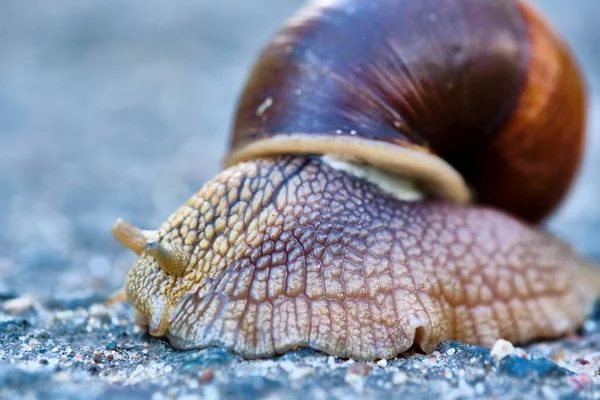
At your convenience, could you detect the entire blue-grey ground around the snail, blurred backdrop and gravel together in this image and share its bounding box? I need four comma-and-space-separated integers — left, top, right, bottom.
0, 0, 600, 399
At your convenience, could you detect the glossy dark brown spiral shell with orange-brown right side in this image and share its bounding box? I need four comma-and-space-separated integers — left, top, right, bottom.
227, 0, 585, 222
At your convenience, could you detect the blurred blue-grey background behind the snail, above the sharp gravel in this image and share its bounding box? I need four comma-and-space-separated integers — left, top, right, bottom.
0, 0, 600, 298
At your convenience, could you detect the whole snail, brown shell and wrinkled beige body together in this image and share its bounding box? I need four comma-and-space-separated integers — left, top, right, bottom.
113, 0, 594, 360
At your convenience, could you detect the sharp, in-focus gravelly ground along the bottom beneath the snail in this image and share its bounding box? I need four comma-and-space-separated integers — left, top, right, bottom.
0, 300, 600, 399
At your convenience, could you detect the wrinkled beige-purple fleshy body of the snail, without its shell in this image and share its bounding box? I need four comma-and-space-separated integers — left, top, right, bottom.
126, 157, 591, 360
